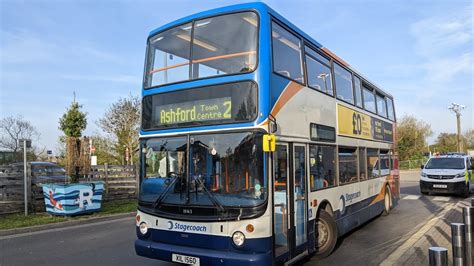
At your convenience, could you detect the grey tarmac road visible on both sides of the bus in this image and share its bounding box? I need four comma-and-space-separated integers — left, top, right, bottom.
0, 171, 460, 265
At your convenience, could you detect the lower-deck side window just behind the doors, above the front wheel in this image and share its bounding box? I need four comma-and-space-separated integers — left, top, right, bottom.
309, 145, 336, 191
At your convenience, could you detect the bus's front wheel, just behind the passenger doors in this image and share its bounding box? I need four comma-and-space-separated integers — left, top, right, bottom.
315, 210, 337, 258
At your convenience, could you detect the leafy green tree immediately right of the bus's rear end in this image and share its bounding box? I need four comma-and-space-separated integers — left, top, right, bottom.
397, 115, 433, 160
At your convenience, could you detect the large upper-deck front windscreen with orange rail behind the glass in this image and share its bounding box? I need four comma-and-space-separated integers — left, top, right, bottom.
144, 12, 258, 88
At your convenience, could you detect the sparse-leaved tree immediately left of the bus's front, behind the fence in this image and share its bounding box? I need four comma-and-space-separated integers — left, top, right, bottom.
97, 95, 140, 164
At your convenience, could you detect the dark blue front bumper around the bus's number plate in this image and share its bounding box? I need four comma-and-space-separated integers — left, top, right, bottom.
135, 239, 273, 266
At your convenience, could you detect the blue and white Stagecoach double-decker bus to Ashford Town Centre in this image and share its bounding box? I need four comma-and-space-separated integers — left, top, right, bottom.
135, 3, 399, 265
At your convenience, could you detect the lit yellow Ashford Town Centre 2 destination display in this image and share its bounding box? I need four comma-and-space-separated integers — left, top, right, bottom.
155, 97, 232, 125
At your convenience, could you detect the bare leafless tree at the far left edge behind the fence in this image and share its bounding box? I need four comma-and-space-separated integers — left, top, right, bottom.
0, 115, 39, 152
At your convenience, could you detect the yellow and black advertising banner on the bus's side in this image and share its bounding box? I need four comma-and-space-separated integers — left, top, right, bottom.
337, 105, 393, 142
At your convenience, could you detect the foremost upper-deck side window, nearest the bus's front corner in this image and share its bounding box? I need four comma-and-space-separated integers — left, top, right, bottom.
272, 22, 304, 83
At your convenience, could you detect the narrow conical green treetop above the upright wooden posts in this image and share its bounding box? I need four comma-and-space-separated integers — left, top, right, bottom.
59, 99, 87, 138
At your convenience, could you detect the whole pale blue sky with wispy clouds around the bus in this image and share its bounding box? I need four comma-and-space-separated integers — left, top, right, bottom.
0, 0, 474, 154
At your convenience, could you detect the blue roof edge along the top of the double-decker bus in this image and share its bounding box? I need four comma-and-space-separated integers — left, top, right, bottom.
148, 2, 393, 98
